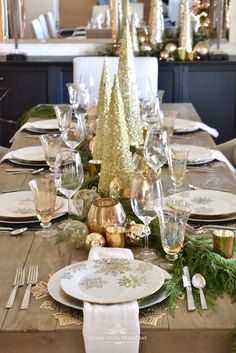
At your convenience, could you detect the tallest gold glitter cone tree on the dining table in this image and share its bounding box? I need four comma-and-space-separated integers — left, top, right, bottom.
118, 20, 143, 146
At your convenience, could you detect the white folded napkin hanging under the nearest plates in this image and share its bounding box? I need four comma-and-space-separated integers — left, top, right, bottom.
83, 247, 140, 353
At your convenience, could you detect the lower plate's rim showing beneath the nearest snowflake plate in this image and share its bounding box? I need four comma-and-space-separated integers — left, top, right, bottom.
48, 264, 171, 310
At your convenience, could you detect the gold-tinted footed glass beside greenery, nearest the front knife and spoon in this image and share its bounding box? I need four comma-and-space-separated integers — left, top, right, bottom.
158, 201, 190, 269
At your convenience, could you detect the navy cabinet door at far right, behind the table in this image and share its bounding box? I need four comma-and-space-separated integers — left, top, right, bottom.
183, 63, 236, 143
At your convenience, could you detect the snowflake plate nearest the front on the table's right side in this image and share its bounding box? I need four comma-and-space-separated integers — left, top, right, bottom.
167, 190, 236, 220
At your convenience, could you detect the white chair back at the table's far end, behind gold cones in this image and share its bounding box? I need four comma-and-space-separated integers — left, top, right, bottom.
73, 56, 158, 97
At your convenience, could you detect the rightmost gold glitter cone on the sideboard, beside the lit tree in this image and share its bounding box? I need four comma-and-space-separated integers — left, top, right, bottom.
179, 0, 193, 53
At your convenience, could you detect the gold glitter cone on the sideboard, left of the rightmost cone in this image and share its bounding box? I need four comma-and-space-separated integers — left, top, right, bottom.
149, 0, 164, 48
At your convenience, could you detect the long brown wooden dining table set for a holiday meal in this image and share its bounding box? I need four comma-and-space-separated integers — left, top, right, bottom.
0, 104, 236, 353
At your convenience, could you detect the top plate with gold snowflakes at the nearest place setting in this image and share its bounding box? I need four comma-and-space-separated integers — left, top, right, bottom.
61, 258, 164, 304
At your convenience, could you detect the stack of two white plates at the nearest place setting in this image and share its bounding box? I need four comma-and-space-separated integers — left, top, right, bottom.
48, 258, 170, 310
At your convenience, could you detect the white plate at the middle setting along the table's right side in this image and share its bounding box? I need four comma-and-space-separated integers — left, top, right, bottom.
171, 144, 215, 164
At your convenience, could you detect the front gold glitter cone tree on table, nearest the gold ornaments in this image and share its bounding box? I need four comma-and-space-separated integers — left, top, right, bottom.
98, 76, 132, 195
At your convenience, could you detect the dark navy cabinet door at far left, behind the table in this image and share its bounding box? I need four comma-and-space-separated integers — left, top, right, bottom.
0, 63, 55, 146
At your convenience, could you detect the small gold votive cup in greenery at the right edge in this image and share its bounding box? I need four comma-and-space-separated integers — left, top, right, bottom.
213, 229, 235, 259
